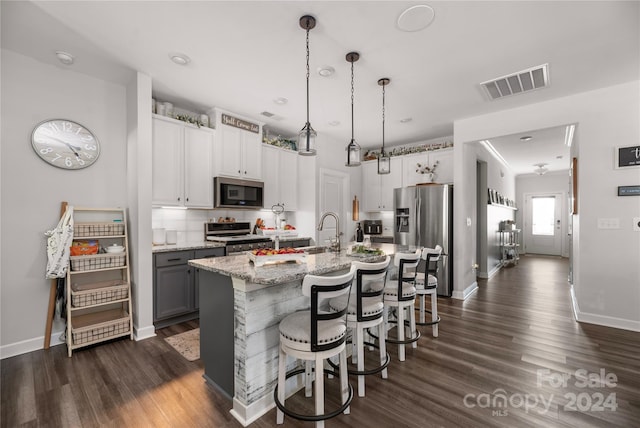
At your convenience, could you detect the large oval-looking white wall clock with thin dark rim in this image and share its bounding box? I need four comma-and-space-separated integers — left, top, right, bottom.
31, 119, 100, 169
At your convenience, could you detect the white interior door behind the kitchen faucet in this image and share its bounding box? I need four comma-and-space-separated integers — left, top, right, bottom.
317, 169, 348, 246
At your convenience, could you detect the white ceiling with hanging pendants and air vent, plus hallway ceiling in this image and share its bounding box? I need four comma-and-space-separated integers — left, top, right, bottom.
0, 1, 640, 174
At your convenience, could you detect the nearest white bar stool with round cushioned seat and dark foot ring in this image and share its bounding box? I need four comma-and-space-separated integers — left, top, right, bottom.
273, 266, 356, 427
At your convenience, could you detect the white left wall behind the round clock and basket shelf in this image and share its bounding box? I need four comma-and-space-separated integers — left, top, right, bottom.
0, 49, 127, 357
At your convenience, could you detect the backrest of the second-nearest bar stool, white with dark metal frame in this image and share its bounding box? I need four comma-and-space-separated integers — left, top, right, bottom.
351, 256, 391, 322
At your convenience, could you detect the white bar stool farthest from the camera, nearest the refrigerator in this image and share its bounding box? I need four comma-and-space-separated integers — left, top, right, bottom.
416, 245, 442, 337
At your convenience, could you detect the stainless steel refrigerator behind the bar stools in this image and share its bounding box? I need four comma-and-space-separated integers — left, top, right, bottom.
393, 184, 453, 297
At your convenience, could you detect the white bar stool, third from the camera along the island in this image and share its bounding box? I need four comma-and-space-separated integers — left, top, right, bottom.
384, 248, 422, 361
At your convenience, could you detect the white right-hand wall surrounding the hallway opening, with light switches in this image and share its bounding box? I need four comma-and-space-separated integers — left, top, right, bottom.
454, 81, 640, 331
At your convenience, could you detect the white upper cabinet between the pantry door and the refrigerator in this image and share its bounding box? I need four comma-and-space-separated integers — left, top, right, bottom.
362, 157, 402, 212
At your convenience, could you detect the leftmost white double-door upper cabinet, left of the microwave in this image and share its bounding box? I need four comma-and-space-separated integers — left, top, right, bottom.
151, 116, 214, 208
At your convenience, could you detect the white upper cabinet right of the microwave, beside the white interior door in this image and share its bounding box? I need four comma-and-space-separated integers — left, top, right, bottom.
262, 145, 298, 211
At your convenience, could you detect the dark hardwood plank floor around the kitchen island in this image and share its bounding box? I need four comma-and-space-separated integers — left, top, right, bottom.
0, 256, 640, 428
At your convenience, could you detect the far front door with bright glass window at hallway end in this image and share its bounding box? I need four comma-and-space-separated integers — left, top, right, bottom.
524, 193, 562, 256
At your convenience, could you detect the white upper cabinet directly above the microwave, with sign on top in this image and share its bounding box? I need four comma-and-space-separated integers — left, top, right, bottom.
215, 109, 263, 180
